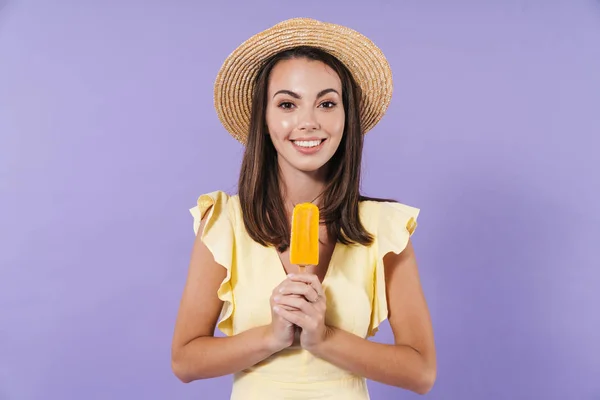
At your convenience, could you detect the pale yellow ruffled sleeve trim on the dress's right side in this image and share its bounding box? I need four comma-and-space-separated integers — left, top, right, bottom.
369, 203, 420, 336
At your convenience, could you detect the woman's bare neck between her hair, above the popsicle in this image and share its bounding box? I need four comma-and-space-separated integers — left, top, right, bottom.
279, 159, 325, 212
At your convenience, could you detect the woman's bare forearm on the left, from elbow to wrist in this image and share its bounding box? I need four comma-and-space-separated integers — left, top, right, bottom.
173, 326, 277, 383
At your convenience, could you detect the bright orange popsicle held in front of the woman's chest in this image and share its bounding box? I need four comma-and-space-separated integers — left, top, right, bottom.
290, 203, 319, 269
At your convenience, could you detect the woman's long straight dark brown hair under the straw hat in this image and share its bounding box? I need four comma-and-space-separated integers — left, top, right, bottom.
238, 47, 393, 252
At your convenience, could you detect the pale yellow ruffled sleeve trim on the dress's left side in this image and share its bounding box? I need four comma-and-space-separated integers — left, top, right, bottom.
190, 191, 235, 336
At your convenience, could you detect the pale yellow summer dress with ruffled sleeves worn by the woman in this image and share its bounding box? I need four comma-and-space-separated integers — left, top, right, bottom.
190, 191, 419, 400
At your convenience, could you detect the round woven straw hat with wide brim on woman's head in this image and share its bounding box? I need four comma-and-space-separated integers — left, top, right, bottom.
214, 18, 393, 144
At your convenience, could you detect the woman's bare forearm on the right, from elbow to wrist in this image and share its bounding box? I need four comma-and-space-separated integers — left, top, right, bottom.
311, 328, 435, 394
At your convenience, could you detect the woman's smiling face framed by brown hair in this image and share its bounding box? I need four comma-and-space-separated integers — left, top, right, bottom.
266, 58, 345, 172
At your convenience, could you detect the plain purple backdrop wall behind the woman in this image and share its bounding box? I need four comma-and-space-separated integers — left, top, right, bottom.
0, 0, 600, 400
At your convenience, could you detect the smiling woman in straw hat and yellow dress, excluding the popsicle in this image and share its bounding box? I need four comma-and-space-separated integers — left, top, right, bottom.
172, 19, 436, 400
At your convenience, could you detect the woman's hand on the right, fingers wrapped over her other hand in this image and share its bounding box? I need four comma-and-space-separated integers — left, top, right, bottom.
275, 274, 329, 351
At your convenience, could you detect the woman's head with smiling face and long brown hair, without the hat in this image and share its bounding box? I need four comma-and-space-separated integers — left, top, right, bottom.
238, 46, 372, 252
